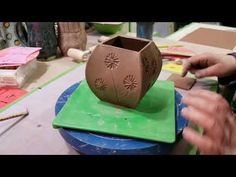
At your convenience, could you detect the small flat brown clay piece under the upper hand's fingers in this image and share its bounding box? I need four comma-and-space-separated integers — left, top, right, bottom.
167, 74, 196, 90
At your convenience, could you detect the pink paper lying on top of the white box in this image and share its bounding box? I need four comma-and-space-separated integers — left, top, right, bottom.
0, 47, 41, 66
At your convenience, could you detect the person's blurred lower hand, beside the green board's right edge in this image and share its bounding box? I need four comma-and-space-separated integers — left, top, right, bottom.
181, 90, 236, 154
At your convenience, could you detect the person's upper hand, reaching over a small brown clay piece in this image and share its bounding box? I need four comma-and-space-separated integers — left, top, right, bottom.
182, 53, 236, 78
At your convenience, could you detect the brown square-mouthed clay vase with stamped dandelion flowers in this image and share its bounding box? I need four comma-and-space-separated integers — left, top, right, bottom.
85, 36, 162, 108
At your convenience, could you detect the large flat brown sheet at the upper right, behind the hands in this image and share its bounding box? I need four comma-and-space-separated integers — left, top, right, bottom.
180, 28, 236, 50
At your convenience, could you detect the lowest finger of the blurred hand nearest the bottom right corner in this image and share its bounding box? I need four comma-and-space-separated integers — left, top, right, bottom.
183, 127, 220, 154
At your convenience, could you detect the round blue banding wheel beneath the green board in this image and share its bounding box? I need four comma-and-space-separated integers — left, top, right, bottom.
55, 83, 187, 155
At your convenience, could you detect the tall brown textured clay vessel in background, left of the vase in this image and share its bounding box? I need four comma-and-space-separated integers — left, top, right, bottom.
58, 22, 87, 56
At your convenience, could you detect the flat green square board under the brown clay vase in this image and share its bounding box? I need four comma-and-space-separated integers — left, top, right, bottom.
53, 80, 176, 143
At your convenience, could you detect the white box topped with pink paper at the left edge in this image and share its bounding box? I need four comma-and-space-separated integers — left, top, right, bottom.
0, 47, 40, 88
